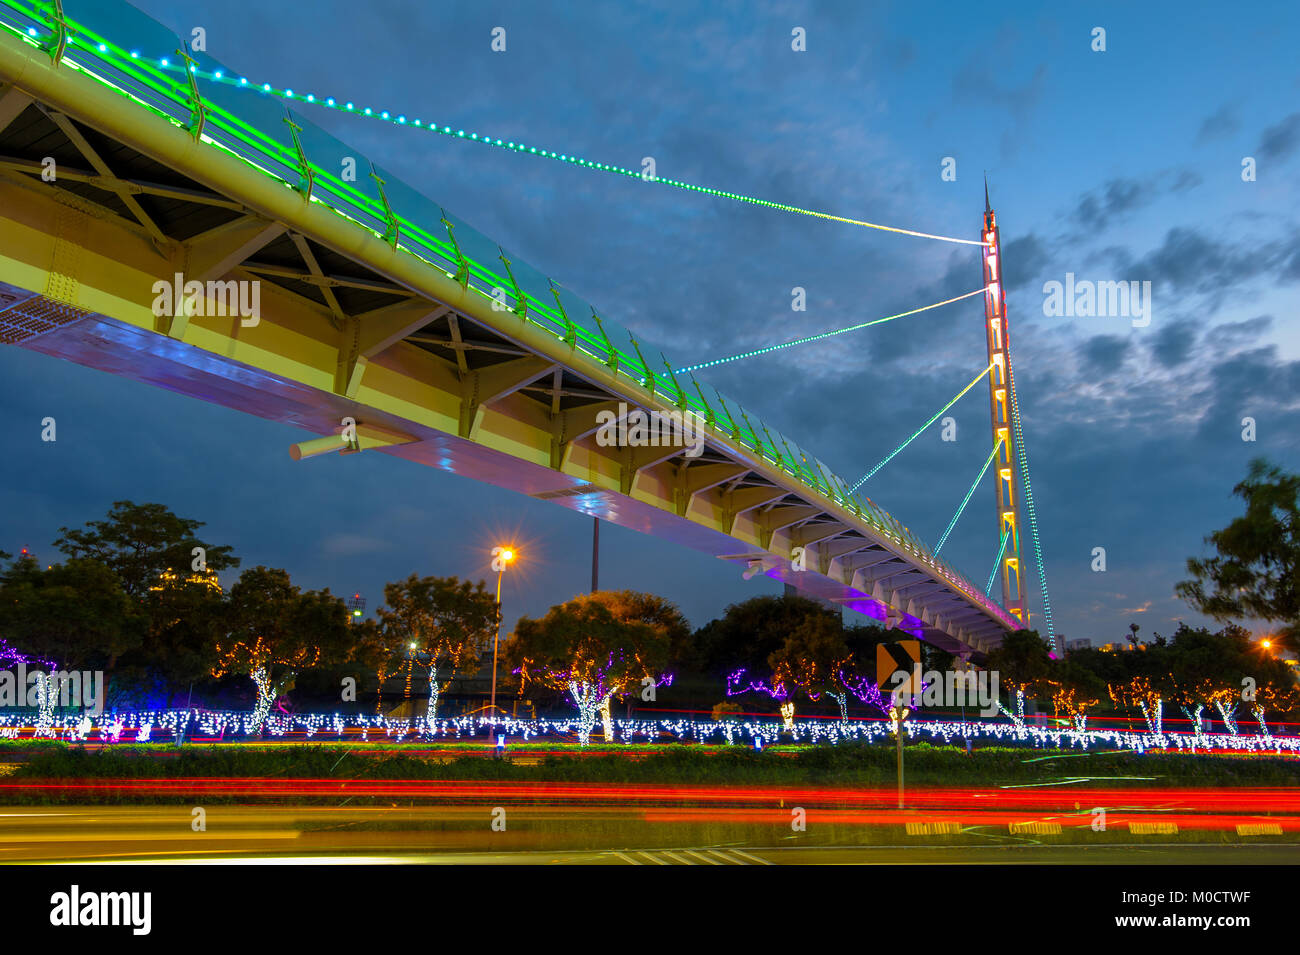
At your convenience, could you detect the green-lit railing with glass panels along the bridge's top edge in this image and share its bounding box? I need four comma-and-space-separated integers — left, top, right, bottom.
0, 0, 1014, 631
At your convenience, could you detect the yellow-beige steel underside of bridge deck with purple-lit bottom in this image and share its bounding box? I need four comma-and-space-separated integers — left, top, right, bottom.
0, 51, 1008, 659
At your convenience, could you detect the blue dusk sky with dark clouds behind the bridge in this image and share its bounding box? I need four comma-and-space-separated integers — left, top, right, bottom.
0, 0, 1300, 643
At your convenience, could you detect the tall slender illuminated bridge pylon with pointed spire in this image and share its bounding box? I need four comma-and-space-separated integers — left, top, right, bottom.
982, 179, 1028, 626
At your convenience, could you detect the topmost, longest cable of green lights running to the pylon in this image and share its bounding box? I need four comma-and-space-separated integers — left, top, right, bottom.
131, 64, 987, 246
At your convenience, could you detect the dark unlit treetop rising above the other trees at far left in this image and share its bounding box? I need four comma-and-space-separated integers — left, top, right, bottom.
55, 500, 239, 598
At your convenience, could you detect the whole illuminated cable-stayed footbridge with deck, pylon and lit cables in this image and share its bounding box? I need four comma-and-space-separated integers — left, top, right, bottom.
0, 0, 1050, 655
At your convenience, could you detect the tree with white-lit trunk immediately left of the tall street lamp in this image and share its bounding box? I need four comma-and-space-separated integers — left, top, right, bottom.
378, 574, 497, 724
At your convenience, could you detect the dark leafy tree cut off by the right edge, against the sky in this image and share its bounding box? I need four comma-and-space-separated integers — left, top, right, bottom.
1177, 457, 1300, 652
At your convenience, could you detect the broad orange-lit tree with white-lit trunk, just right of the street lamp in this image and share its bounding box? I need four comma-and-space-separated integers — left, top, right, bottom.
506, 592, 672, 746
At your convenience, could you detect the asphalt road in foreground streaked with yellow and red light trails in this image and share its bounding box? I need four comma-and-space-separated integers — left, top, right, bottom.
0, 804, 1300, 865
